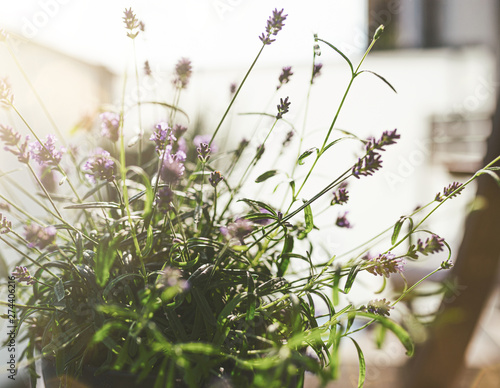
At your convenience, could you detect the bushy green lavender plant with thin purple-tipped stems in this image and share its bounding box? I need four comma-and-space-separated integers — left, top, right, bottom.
0, 9, 498, 387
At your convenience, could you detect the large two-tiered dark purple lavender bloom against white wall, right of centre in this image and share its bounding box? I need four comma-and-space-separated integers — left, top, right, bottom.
352, 129, 401, 179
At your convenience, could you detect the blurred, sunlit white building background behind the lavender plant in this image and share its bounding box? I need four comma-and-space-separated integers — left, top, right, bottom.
0, 0, 500, 387
